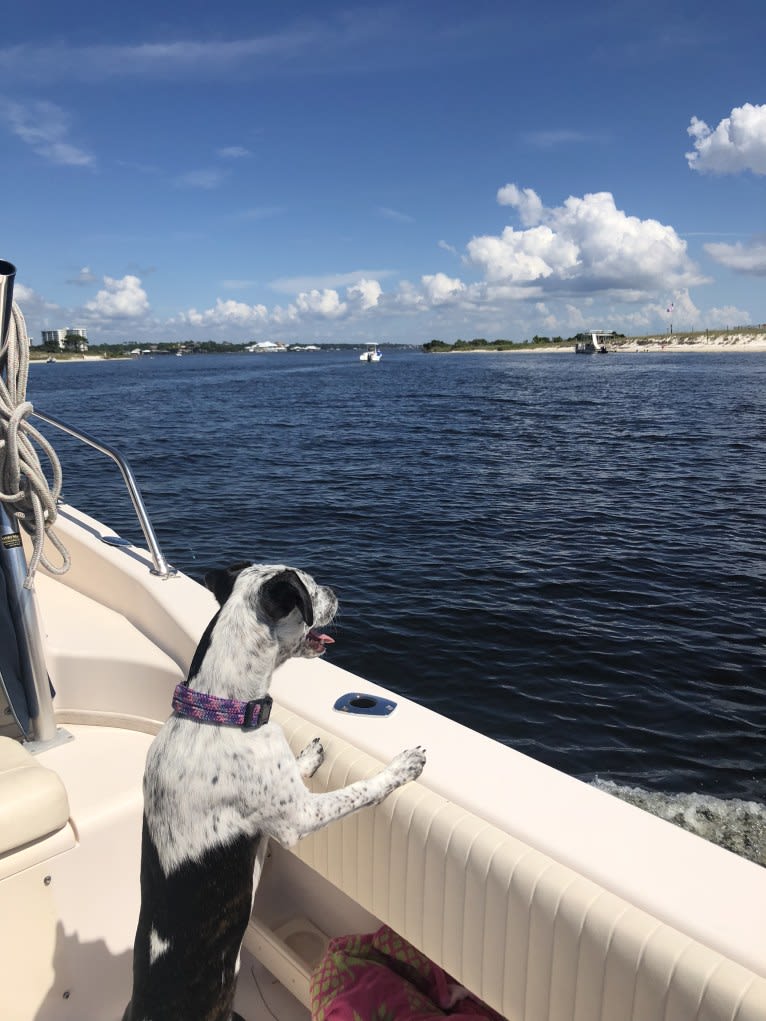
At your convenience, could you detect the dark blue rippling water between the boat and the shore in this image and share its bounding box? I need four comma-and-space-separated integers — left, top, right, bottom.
28, 351, 766, 864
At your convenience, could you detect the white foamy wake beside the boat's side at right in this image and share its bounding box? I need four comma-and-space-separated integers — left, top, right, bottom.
592, 778, 766, 866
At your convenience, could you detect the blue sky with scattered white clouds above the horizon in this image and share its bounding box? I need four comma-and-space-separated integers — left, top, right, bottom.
0, 0, 766, 343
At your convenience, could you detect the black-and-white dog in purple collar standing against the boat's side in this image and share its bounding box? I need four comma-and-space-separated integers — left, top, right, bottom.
123, 563, 425, 1021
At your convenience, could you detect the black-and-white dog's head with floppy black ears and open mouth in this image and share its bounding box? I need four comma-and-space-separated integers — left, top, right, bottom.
204, 563, 338, 664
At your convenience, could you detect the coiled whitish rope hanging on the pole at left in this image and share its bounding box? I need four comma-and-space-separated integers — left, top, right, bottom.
0, 302, 69, 588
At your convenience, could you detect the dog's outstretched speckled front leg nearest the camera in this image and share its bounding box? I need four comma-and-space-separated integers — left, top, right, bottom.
269, 745, 426, 847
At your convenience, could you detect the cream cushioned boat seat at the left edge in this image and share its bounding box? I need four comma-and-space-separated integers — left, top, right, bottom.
0, 737, 69, 855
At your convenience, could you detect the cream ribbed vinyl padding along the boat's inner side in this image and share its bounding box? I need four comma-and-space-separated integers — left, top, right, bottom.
275, 710, 766, 1021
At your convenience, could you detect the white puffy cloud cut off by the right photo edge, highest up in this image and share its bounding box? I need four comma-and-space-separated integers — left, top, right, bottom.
686, 103, 766, 175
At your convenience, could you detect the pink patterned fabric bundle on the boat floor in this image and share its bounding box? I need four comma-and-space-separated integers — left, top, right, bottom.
310, 925, 502, 1021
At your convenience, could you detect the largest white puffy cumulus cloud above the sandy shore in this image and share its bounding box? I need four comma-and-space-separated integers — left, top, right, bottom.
467, 184, 703, 300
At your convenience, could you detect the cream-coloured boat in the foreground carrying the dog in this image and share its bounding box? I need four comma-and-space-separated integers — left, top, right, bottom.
0, 262, 766, 1021
